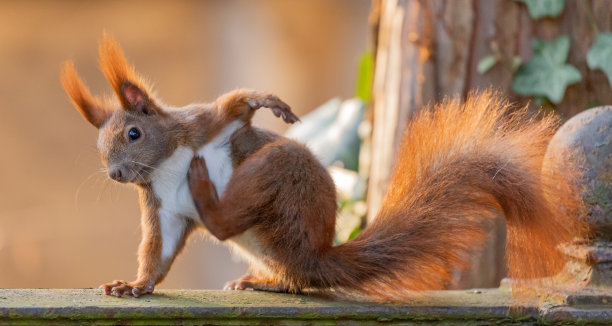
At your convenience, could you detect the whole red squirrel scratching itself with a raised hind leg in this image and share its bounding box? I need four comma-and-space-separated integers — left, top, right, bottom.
62, 36, 584, 300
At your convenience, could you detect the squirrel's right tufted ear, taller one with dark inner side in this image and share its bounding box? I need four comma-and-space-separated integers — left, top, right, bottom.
98, 33, 163, 114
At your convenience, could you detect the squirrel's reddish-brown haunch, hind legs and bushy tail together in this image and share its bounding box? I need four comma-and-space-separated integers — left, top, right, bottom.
190, 92, 585, 300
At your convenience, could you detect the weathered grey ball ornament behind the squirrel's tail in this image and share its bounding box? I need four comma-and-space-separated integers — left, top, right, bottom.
545, 106, 612, 239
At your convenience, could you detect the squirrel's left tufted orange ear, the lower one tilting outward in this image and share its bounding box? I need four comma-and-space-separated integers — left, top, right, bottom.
61, 61, 112, 128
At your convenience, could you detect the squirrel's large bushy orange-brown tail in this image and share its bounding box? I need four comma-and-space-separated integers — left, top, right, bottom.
324, 91, 585, 298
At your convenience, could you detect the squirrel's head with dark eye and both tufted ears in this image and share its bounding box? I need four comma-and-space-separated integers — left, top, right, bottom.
61, 35, 179, 184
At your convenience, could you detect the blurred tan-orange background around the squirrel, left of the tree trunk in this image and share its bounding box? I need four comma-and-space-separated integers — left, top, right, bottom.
0, 0, 370, 289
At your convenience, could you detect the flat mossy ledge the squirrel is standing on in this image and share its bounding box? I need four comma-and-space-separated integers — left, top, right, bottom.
0, 289, 612, 325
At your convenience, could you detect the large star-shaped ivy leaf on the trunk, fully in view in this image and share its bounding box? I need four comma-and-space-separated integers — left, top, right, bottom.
512, 35, 582, 104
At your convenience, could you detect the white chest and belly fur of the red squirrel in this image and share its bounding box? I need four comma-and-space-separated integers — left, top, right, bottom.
152, 121, 265, 271
